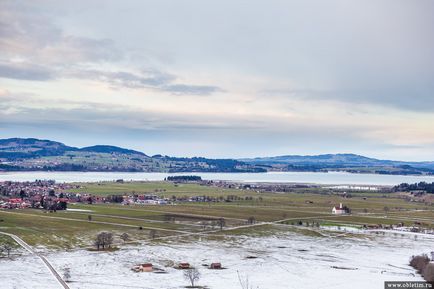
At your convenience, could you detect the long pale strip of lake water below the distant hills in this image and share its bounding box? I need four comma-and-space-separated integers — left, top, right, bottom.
0, 172, 434, 186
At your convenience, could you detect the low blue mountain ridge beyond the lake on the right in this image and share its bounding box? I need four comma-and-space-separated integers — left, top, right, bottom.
240, 154, 434, 174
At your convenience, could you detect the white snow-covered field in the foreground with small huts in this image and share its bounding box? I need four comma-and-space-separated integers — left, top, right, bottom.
0, 233, 434, 289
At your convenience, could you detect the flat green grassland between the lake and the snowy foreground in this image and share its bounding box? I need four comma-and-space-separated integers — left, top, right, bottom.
0, 182, 434, 248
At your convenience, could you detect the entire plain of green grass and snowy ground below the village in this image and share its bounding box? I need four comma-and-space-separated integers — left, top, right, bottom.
0, 182, 434, 289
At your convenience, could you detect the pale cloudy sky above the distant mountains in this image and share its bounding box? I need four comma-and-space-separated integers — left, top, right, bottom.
0, 0, 434, 161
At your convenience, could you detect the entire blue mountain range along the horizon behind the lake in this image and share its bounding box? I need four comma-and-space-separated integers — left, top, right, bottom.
0, 138, 434, 175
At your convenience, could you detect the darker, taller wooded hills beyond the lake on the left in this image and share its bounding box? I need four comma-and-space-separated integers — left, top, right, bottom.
0, 138, 266, 172
